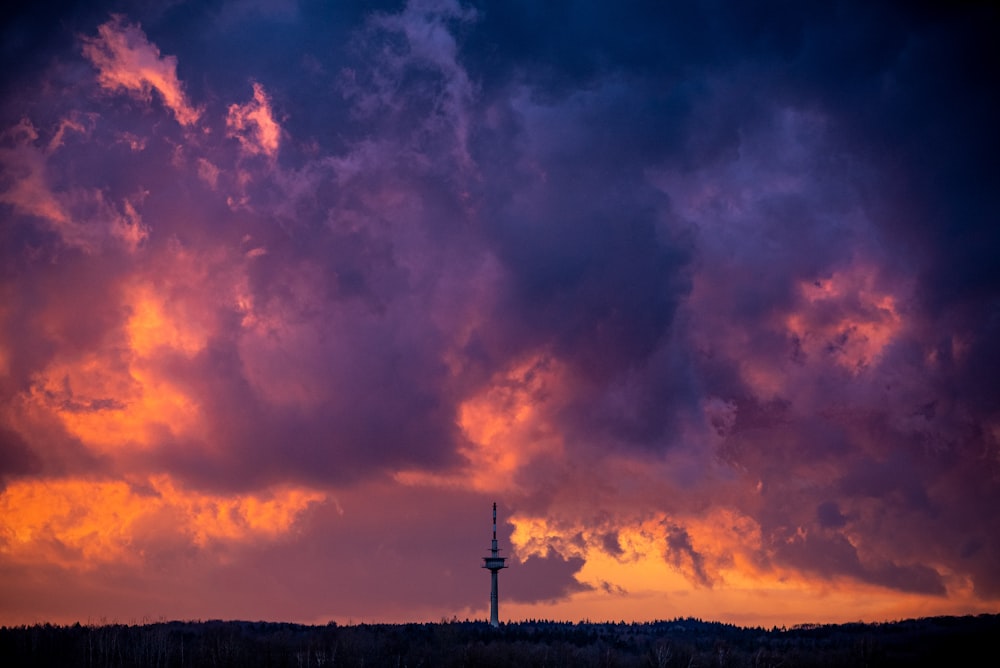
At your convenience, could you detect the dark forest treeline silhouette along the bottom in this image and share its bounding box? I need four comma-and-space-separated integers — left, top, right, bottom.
0, 615, 1000, 668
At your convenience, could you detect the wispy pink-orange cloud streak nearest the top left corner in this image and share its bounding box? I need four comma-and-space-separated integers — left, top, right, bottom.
83, 16, 200, 125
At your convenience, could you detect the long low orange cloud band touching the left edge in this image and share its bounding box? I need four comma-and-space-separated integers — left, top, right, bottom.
0, 475, 325, 569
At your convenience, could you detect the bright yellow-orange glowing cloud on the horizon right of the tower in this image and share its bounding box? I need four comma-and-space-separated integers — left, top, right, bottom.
503, 508, 989, 625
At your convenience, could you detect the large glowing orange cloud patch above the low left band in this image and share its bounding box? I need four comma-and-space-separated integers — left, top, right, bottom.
14, 248, 252, 453
